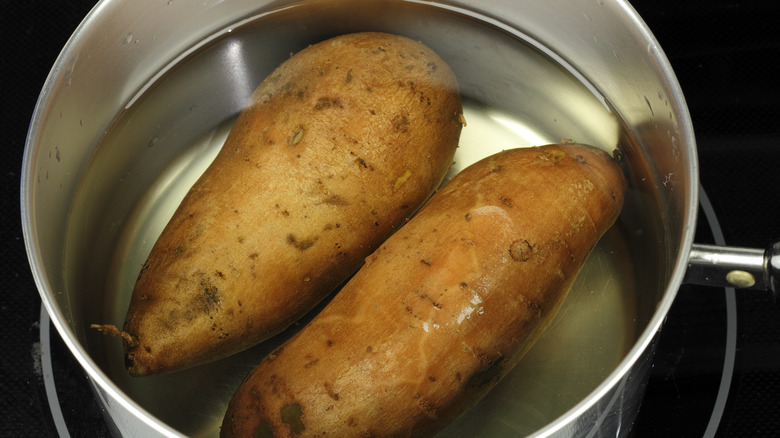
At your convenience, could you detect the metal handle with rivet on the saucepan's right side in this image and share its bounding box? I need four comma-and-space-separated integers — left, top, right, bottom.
683, 241, 780, 303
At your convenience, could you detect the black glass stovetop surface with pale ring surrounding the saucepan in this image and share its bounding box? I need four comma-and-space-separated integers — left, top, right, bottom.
0, 0, 780, 437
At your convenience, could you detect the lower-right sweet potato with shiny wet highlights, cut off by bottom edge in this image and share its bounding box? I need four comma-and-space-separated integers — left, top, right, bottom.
222, 145, 626, 437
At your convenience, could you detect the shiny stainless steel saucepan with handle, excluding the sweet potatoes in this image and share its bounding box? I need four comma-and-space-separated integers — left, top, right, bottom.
21, 0, 780, 436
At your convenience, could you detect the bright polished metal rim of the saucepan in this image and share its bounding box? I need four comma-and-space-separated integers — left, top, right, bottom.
20, 0, 699, 437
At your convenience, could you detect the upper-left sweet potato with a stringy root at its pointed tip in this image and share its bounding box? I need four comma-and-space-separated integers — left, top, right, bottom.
123, 33, 462, 376
